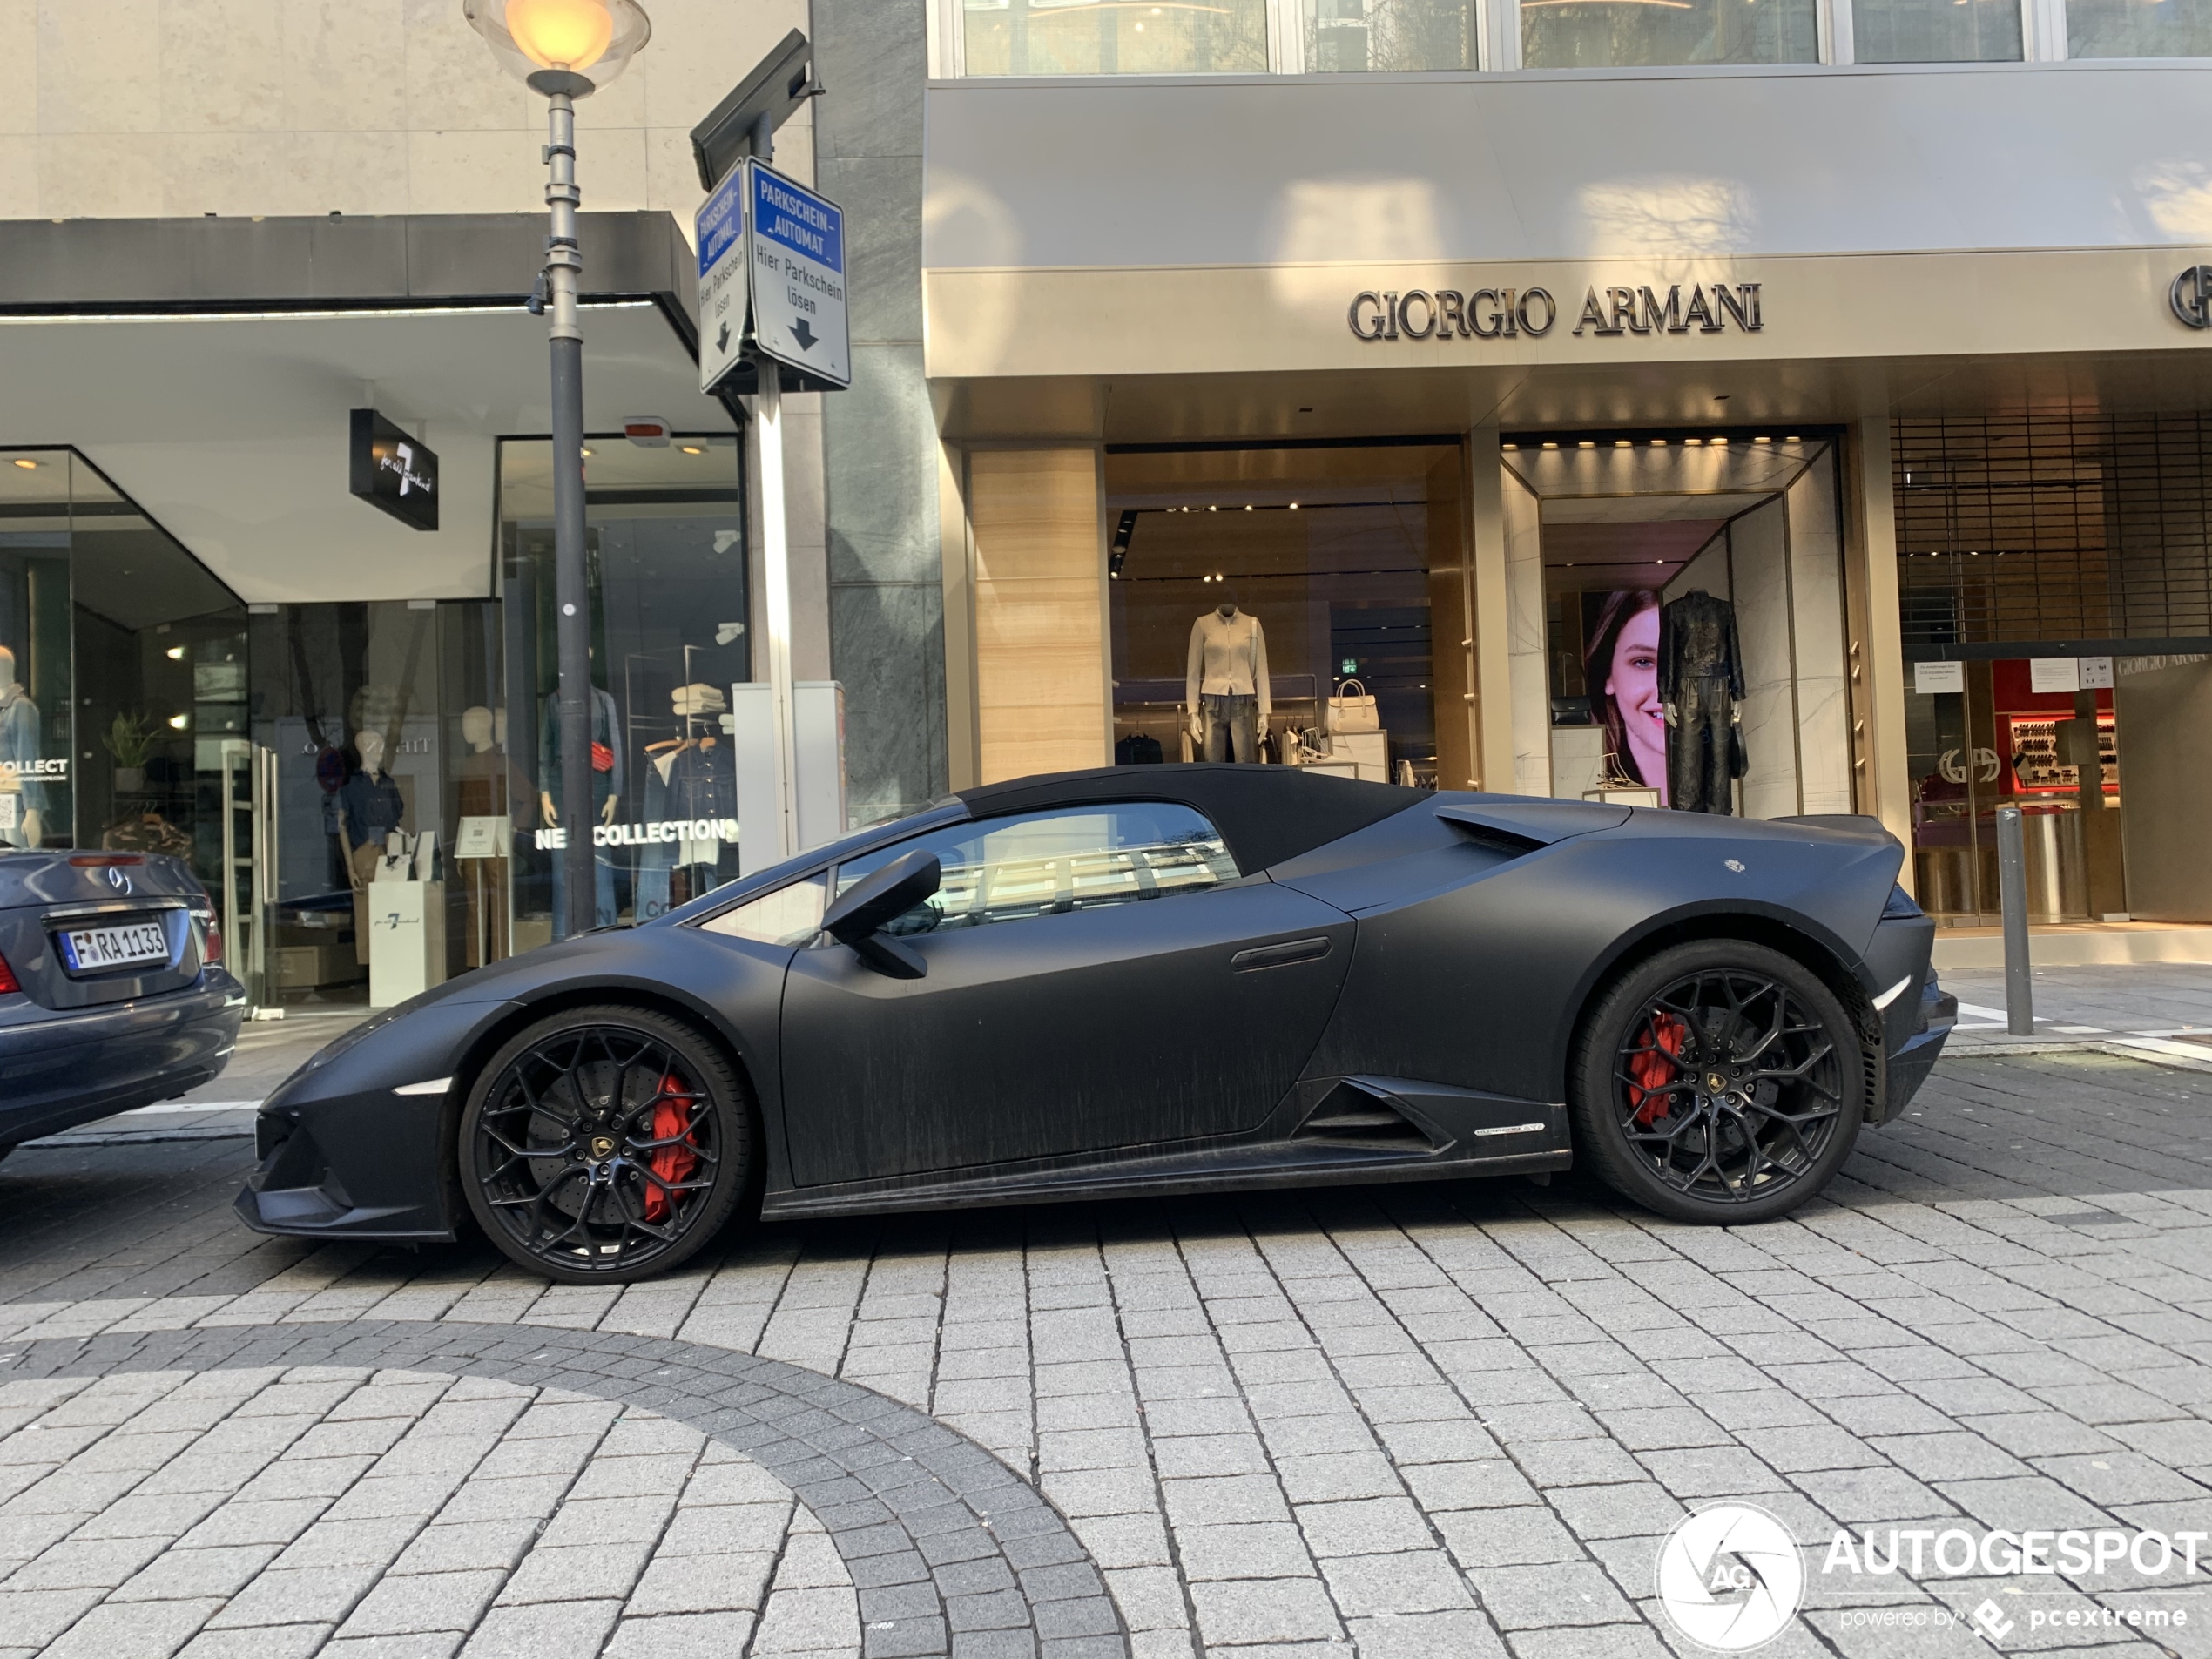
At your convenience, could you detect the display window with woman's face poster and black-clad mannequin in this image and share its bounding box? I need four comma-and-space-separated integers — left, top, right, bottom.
1498, 434, 1856, 819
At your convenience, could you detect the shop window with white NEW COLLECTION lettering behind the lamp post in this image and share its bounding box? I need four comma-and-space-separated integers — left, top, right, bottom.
500, 434, 752, 951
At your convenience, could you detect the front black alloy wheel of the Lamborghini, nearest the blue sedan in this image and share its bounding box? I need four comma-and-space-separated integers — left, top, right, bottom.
458, 1007, 754, 1285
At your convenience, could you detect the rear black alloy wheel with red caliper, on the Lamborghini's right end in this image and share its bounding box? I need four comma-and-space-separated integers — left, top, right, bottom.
1570, 941, 1869, 1225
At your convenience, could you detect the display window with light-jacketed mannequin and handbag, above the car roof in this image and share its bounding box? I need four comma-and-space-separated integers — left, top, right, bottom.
1106, 445, 1474, 787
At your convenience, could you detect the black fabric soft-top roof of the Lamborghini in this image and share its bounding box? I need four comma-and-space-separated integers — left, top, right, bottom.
958, 761, 1429, 876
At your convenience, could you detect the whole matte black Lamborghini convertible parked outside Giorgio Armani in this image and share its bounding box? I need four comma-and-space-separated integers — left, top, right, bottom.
239, 765, 1955, 1283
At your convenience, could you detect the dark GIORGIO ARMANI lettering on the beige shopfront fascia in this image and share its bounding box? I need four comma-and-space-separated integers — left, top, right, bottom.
1345, 283, 1763, 341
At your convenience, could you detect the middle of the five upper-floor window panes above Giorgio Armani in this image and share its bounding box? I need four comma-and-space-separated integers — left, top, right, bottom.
1520, 0, 1820, 69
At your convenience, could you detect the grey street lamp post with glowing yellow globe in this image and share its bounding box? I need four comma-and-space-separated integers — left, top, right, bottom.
460, 0, 652, 934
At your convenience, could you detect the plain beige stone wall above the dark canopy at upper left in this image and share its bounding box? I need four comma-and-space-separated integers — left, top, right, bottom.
0, 0, 822, 221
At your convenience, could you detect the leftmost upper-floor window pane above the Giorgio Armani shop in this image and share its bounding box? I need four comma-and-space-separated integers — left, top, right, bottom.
960, 0, 1267, 75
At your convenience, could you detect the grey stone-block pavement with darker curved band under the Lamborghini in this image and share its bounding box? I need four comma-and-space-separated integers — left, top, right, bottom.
0, 1051, 2212, 1659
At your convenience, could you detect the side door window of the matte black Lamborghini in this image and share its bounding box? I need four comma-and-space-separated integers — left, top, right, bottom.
836, 800, 1238, 934
